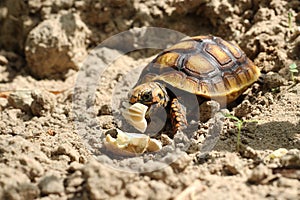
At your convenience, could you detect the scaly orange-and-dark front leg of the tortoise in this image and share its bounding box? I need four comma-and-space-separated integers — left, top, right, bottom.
170, 98, 187, 135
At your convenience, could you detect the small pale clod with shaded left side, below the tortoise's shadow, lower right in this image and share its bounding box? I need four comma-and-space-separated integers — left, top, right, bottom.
248, 164, 272, 184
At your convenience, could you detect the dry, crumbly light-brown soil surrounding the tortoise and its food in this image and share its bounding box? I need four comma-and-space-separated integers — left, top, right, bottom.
0, 0, 300, 200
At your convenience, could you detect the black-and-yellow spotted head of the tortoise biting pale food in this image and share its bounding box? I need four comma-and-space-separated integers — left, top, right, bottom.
129, 82, 169, 107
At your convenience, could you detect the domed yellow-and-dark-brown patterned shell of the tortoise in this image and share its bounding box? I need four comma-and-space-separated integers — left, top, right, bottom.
137, 36, 260, 104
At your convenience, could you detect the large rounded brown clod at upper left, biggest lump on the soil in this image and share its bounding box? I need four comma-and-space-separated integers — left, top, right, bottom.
25, 13, 91, 78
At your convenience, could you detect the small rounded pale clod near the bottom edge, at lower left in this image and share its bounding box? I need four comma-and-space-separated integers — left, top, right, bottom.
38, 176, 64, 195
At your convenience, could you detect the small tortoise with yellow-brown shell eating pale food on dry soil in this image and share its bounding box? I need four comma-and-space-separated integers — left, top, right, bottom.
123, 35, 260, 134
